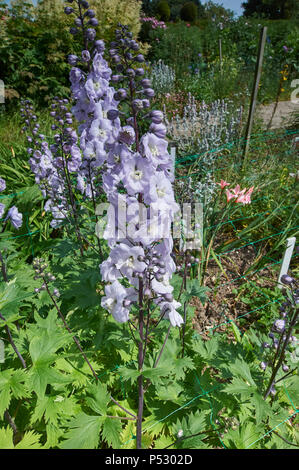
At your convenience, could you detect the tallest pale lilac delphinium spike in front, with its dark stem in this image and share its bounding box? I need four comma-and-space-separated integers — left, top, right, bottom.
96, 25, 183, 449
